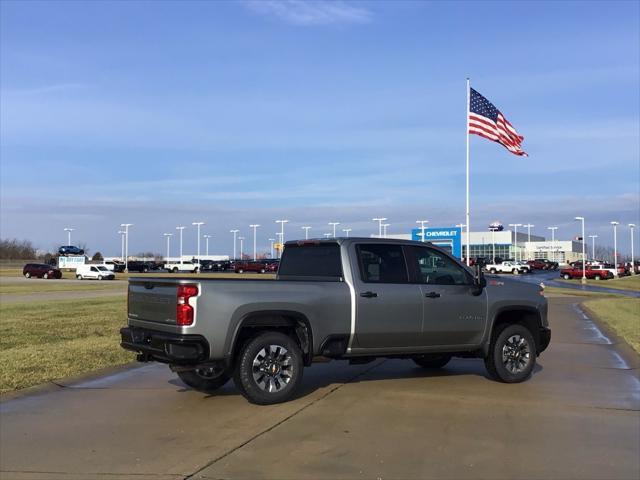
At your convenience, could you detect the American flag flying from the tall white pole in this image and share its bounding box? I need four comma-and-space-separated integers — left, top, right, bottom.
469, 88, 528, 157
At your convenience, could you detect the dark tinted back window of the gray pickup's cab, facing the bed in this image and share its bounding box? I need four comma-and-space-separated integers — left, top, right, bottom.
278, 242, 343, 282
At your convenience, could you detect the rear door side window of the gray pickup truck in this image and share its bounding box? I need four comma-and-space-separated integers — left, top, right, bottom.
357, 244, 409, 283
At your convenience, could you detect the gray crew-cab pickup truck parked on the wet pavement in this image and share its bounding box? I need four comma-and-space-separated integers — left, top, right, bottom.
121, 238, 551, 404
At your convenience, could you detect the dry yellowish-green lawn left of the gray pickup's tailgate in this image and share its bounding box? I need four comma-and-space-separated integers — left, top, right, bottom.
0, 297, 134, 393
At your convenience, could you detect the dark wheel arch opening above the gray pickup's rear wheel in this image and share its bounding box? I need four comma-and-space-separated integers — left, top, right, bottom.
228, 310, 313, 366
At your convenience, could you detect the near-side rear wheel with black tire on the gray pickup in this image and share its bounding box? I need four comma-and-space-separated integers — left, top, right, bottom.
233, 332, 304, 405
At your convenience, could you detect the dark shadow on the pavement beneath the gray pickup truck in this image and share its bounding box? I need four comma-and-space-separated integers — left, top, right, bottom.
168, 359, 544, 401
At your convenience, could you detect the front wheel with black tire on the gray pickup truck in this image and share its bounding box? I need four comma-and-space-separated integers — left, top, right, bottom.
484, 323, 536, 383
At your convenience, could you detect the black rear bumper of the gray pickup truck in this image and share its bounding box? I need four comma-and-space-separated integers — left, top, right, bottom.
120, 327, 209, 365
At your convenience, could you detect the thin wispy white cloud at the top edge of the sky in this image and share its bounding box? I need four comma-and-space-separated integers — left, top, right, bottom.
244, 0, 372, 26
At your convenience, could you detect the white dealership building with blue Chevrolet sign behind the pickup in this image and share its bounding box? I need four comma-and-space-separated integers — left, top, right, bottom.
380, 227, 582, 263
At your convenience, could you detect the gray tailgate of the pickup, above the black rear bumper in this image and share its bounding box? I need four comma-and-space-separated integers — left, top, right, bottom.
127, 280, 178, 325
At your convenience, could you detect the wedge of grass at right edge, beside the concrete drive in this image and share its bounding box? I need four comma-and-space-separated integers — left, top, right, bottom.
583, 297, 640, 353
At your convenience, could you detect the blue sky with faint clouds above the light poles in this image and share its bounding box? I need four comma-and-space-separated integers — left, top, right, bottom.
0, 0, 640, 254
